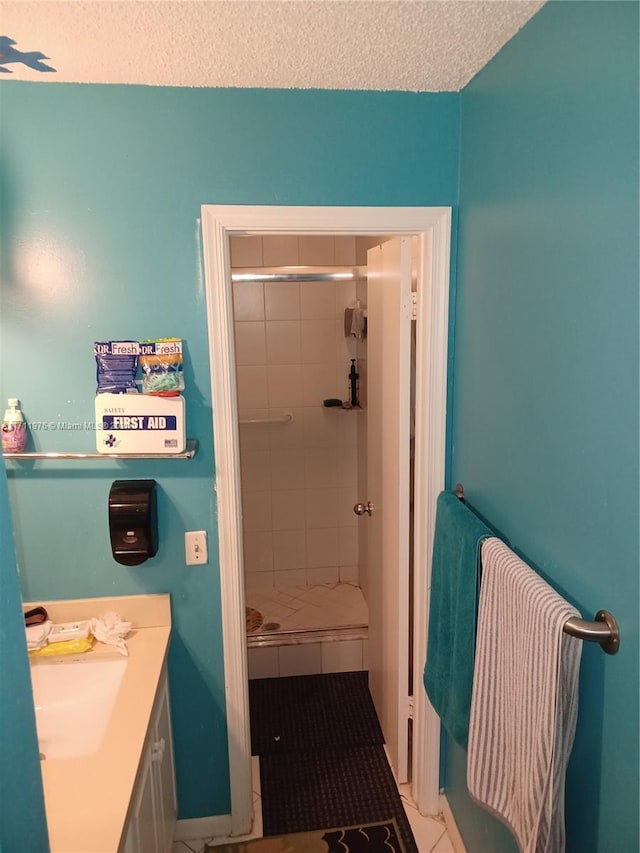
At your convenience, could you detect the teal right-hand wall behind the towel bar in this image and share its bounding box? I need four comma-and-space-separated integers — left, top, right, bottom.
447, 2, 639, 853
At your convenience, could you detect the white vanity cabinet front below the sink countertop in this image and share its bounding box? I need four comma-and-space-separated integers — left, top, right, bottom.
121, 665, 176, 853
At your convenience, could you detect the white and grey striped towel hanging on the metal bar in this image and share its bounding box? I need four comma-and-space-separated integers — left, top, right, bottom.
467, 537, 582, 853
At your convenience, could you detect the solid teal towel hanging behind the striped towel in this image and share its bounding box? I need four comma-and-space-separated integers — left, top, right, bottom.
424, 491, 493, 748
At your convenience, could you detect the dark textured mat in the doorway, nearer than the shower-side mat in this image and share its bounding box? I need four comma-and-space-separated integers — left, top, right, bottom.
260, 746, 418, 853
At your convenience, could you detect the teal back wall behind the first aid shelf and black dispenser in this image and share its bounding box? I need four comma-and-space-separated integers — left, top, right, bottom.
0, 81, 460, 818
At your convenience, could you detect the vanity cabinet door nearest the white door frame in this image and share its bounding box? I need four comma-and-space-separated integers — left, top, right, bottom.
152, 680, 177, 853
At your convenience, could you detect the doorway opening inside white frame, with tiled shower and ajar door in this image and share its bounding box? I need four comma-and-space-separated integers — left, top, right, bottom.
230, 235, 410, 783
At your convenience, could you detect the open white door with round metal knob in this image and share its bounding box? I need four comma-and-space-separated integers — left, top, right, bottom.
359, 237, 411, 782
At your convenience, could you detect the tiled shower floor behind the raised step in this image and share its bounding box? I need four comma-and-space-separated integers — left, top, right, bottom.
245, 583, 368, 645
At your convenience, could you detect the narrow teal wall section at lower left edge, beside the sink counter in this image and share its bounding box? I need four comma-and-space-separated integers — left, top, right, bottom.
0, 459, 49, 853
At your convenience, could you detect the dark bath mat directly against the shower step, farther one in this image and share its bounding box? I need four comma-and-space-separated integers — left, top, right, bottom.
249, 671, 384, 756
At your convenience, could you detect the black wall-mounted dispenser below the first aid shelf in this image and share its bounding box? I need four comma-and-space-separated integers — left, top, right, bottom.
109, 480, 158, 566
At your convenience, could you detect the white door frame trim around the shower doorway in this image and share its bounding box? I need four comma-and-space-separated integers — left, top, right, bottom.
202, 205, 451, 835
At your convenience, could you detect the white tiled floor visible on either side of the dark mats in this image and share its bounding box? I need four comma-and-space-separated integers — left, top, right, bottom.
172, 756, 459, 853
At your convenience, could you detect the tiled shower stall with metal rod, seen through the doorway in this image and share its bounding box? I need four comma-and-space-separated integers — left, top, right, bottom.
230, 236, 381, 678
